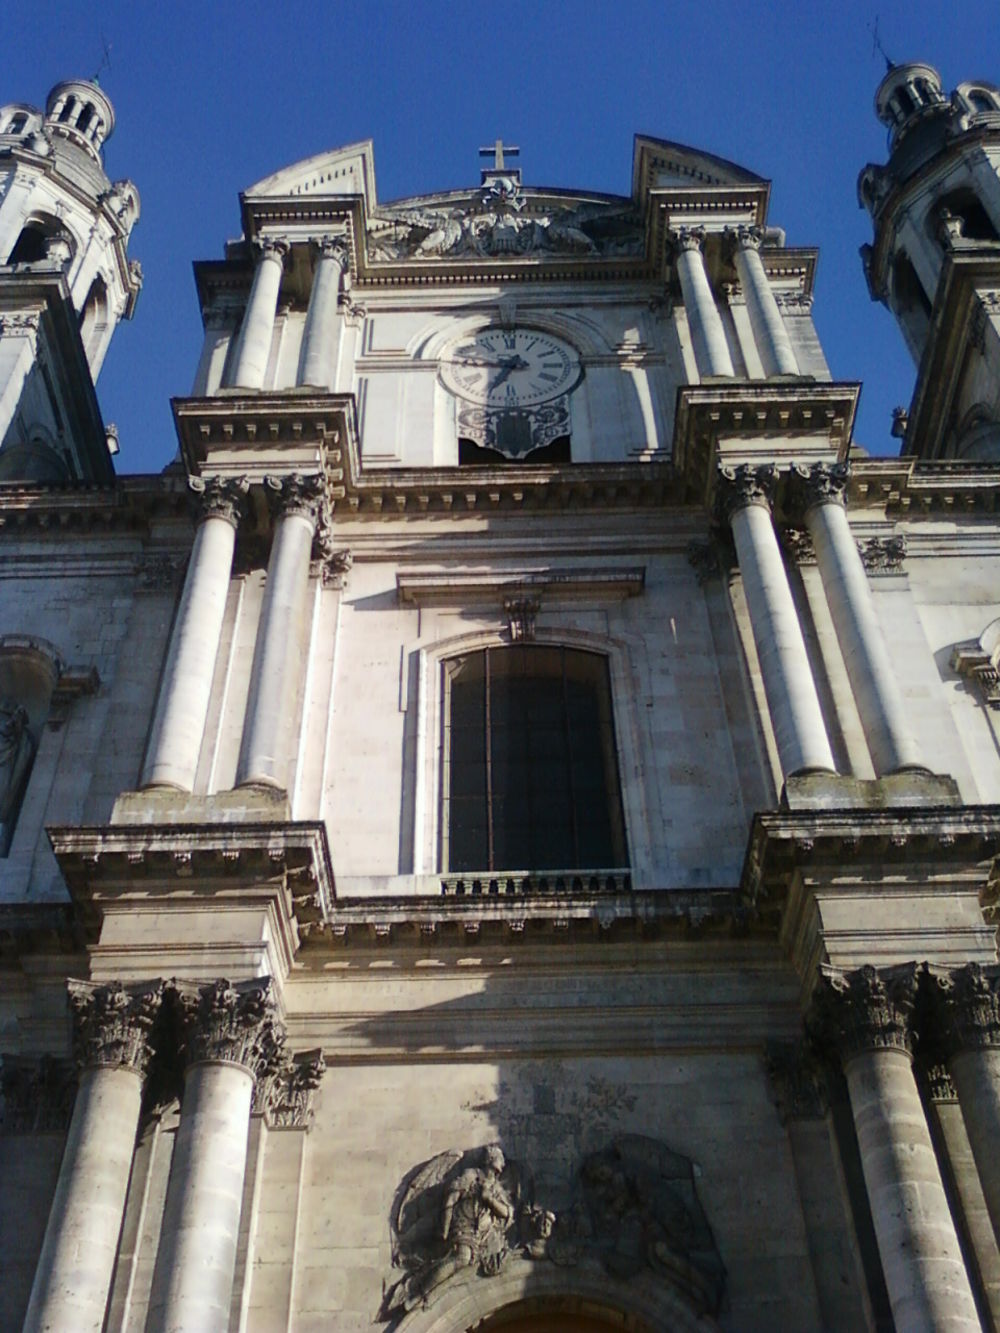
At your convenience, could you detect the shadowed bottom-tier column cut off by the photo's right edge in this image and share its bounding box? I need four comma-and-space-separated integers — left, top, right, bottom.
937, 962, 1000, 1241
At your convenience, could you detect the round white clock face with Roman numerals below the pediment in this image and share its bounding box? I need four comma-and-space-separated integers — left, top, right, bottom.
441, 328, 580, 411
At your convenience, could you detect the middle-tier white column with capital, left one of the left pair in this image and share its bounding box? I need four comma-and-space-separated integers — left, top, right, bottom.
140, 477, 247, 792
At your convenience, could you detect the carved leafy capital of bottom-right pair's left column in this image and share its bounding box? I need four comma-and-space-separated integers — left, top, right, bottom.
809, 962, 917, 1060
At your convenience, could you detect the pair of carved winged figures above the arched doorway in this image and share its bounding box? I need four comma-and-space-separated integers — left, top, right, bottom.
379, 1134, 724, 1321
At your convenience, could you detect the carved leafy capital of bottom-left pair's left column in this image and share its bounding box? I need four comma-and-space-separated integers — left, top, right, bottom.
68, 978, 163, 1078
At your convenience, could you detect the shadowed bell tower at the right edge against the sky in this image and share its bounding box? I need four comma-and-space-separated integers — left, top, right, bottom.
857, 63, 1000, 461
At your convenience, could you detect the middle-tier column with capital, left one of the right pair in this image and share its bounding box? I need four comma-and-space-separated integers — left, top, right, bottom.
719, 464, 835, 778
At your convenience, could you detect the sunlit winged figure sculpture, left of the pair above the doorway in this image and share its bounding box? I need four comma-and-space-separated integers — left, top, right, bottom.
381, 1144, 535, 1318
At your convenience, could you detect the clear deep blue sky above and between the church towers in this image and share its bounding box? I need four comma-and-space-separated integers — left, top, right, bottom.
0, 0, 1000, 472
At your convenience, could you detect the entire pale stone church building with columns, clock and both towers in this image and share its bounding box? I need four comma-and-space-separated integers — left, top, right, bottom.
0, 64, 1000, 1333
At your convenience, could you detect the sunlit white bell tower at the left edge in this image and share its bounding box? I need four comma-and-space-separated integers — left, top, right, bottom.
0, 79, 141, 484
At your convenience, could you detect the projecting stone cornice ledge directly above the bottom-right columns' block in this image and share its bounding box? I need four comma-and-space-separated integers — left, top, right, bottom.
740, 805, 1000, 914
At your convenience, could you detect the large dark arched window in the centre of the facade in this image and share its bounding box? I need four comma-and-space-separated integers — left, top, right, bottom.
441, 644, 628, 872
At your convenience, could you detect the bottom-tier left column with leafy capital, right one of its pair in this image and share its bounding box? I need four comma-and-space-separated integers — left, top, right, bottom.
145, 978, 284, 1333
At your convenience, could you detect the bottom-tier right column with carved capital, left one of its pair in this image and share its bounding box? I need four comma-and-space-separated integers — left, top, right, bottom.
813, 964, 980, 1333
